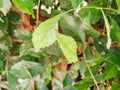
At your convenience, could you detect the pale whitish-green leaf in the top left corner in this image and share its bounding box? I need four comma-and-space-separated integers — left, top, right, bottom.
0, 0, 12, 15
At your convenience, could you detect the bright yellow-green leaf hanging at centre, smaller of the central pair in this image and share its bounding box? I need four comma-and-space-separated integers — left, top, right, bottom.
56, 32, 78, 62
